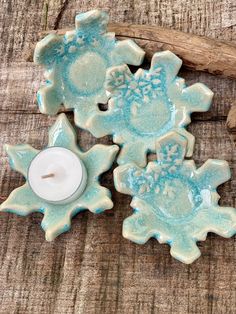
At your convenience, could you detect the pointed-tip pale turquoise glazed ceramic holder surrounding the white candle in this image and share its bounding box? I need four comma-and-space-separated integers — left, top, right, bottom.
0, 114, 118, 241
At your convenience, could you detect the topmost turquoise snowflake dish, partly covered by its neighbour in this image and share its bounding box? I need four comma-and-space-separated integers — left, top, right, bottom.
34, 10, 144, 128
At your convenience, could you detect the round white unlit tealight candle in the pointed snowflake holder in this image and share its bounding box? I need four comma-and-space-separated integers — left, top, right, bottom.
28, 147, 87, 203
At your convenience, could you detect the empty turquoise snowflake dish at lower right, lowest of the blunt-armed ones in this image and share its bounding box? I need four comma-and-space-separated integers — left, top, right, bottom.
114, 132, 236, 264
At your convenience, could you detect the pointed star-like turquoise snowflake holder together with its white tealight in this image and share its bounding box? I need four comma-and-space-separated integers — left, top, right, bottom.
0, 114, 118, 241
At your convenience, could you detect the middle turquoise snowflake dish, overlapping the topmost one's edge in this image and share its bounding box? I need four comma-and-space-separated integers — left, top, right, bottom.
87, 51, 213, 166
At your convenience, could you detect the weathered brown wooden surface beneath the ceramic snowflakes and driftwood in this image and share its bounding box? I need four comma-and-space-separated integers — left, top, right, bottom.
0, 0, 236, 314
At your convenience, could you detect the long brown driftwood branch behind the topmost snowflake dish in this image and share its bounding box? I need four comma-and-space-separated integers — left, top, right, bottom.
34, 23, 236, 78
